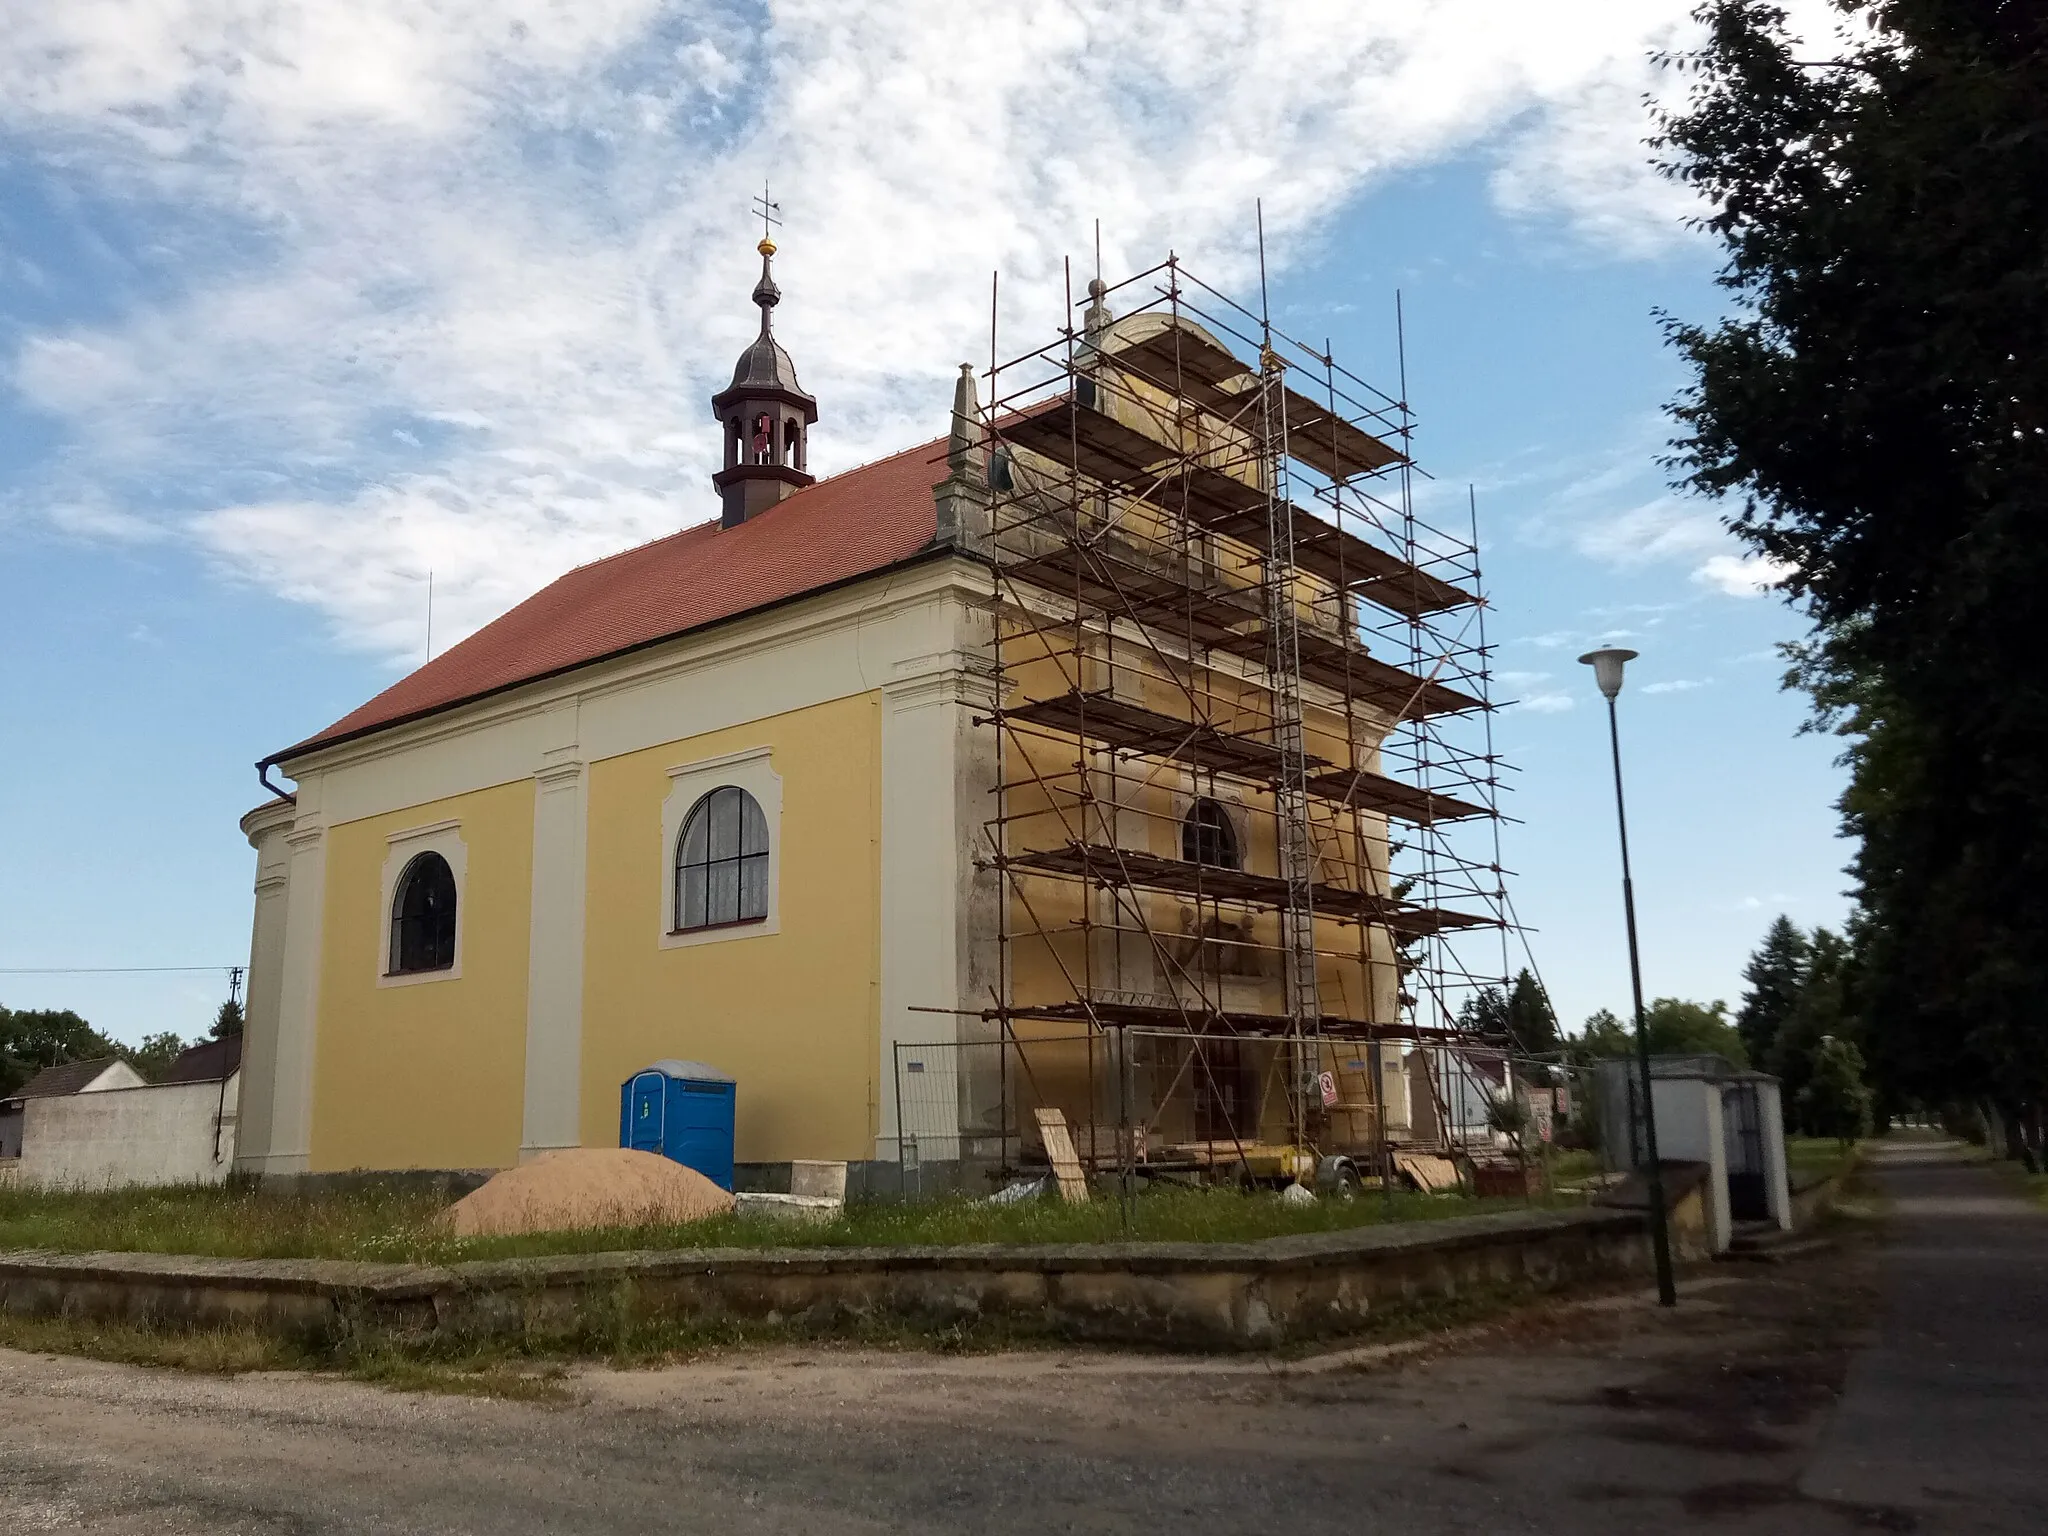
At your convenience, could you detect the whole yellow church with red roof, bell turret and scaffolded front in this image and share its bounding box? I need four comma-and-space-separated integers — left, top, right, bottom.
238, 240, 1485, 1176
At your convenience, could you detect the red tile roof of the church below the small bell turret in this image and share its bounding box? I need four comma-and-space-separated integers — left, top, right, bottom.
276, 438, 946, 762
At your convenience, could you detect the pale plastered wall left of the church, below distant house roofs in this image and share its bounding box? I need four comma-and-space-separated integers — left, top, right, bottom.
16, 1079, 238, 1190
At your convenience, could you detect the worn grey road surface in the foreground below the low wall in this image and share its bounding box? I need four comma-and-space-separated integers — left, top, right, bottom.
0, 1153, 2048, 1536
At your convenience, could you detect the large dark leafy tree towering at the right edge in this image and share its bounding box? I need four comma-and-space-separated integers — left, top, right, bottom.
1657, 0, 2048, 1124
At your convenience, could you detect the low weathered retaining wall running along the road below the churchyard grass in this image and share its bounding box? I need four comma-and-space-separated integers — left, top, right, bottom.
0, 1210, 1651, 1348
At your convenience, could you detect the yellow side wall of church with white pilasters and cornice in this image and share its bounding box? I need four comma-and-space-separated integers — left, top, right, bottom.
242, 557, 987, 1174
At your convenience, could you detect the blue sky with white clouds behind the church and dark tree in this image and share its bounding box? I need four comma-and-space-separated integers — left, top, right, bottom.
0, 0, 1847, 1040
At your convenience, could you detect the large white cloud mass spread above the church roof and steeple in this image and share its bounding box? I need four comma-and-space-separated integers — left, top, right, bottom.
0, 0, 1704, 657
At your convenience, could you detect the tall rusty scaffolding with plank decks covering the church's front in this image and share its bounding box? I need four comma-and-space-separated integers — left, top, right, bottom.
895, 258, 1509, 1180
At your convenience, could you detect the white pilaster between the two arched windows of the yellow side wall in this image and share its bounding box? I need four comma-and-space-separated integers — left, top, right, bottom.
518, 733, 588, 1161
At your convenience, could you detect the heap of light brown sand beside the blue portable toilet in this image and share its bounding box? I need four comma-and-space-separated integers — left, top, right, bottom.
442, 1147, 733, 1237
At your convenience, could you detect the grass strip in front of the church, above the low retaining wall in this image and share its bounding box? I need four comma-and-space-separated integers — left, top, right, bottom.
0, 1188, 1579, 1264
